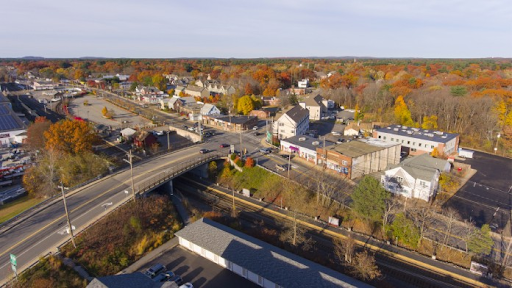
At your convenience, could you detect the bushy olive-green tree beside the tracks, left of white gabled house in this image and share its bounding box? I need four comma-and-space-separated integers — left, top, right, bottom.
351, 176, 391, 223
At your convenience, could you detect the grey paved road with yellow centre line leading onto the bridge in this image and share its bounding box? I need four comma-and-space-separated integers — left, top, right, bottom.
0, 147, 224, 283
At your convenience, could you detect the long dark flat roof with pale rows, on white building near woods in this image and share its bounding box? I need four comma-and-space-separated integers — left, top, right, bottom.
375, 125, 459, 143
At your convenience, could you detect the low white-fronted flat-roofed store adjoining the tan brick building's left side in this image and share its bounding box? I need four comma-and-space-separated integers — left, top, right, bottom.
280, 135, 335, 164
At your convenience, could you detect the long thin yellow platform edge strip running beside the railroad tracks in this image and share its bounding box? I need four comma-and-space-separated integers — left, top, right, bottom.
191, 180, 485, 287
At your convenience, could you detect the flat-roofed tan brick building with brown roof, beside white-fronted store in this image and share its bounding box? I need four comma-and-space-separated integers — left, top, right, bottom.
316, 138, 400, 179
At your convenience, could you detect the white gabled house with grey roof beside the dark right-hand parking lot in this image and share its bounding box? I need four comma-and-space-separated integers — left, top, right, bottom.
381, 153, 451, 201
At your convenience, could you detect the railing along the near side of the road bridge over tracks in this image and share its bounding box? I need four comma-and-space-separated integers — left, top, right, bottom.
135, 153, 226, 194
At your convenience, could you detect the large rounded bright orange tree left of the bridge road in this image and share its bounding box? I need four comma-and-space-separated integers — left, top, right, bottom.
44, 119, 97, 154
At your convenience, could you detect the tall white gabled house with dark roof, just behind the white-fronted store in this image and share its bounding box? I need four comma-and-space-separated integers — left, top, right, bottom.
272, 105, 309, 139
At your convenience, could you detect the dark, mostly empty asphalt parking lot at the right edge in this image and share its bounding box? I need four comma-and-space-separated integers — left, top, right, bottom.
444, 151, 512, 232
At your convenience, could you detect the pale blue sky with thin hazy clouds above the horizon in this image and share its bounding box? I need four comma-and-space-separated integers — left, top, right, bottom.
0, 0, 512, 58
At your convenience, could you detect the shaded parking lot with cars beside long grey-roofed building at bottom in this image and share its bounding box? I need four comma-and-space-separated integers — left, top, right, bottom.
139, 245, 260, 288
